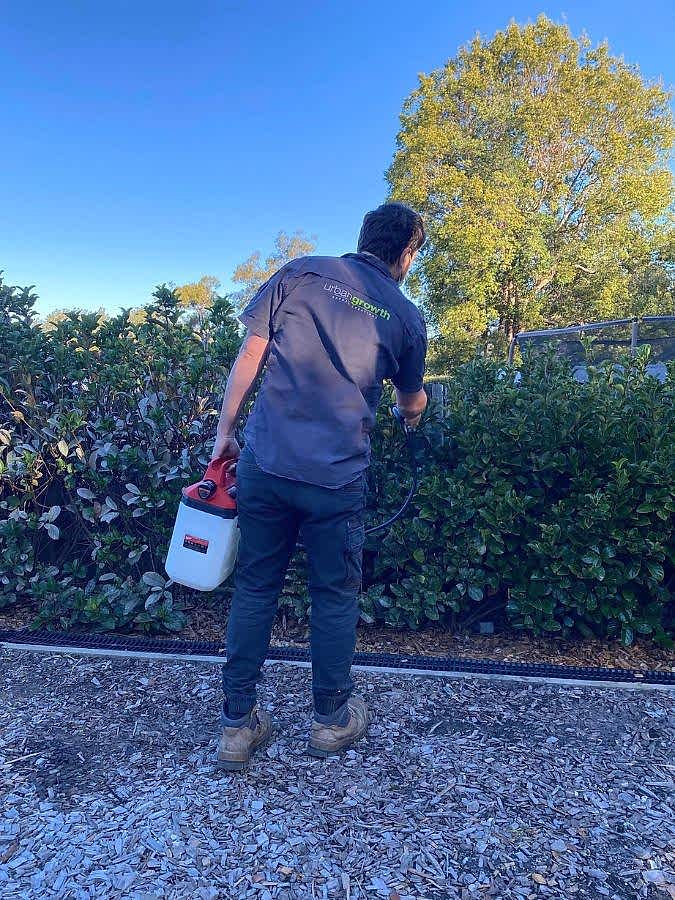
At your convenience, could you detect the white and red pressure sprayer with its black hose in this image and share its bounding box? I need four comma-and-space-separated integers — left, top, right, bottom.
165, 406, 417, 591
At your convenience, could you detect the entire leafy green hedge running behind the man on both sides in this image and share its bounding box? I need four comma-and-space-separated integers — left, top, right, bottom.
0, 270, 675, 643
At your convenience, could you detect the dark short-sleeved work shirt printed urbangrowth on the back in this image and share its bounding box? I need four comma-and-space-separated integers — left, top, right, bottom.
239, 253, 427, 488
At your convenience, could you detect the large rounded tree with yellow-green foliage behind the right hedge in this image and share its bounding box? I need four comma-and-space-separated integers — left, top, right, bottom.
388, 16, 673, 364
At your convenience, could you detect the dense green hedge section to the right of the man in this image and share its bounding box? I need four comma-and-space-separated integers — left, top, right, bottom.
364, 352, 675, 644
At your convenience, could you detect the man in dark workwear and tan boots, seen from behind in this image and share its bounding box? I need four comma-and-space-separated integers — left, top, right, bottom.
213, 203, 427, 769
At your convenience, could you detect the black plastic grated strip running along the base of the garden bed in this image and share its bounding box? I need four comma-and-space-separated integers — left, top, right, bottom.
0, 629, 675, 686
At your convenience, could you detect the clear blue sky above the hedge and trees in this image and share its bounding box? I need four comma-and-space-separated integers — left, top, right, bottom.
0, 0, 675, 312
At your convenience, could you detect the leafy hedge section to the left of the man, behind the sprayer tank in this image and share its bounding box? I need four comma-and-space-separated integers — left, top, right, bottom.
0, 281, 240, 631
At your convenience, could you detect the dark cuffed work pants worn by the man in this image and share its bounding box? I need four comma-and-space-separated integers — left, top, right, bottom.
223, 448, 365, 719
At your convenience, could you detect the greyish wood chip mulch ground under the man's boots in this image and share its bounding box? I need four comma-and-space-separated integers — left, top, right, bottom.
0, 650, 675, 900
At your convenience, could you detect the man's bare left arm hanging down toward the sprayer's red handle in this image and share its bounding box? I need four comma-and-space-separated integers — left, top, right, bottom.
211, 331, 269, 459
